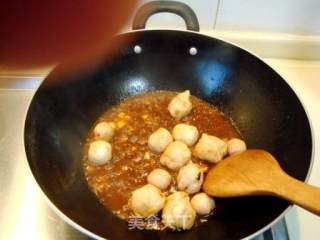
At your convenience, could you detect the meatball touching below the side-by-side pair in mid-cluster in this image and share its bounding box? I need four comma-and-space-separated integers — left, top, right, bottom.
160, 141, 191, 170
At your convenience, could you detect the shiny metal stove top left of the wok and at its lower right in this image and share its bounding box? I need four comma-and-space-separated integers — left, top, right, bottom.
0, 76, 289, 240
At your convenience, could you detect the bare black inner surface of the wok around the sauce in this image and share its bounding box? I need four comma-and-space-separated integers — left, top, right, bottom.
25, 30, 312, 240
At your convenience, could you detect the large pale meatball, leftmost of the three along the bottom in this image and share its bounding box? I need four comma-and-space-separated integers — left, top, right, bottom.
129, 184, 166, 217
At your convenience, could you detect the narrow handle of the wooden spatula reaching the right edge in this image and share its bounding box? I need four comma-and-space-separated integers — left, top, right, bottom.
274, 174, 320, 216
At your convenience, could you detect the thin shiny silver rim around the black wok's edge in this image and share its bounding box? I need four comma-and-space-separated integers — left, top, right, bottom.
23, 28, 315, 240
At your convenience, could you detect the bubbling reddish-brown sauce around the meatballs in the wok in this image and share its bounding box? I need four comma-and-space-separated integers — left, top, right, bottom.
84, 91, 240, 229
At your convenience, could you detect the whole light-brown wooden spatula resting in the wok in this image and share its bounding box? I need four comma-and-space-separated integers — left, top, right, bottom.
203, 150, 320, 216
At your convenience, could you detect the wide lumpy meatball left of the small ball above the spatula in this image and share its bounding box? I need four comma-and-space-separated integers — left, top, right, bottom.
193, 133, 227, 163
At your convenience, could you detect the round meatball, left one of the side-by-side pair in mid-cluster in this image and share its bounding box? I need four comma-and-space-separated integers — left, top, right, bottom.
148, 128, 173, 153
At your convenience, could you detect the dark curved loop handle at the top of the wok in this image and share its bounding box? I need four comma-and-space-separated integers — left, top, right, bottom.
132, 1, 200, 32
